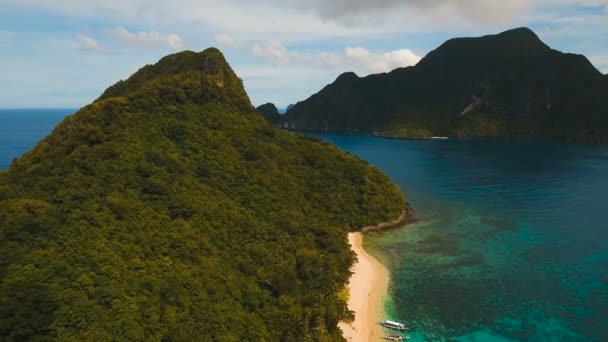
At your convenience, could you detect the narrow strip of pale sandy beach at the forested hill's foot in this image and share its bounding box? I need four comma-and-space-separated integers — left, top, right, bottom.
338, 233, 389, 342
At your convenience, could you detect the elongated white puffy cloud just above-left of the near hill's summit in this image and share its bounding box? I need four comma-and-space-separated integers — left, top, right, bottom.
106, 27, 183, 50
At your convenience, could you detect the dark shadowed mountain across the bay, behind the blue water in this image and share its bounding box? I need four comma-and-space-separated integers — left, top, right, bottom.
281, 28, 608, 142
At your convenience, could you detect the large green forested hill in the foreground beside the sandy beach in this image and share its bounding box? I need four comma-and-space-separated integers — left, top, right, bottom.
0, 49, 404, 341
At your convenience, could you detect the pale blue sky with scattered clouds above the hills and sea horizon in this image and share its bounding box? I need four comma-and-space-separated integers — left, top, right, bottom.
0, 0, 608, 108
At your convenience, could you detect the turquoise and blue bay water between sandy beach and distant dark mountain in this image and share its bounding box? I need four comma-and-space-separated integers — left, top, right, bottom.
321, 135, 608, 341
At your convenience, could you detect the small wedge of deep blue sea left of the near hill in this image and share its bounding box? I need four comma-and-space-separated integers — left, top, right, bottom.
0, 109, 76, 170
